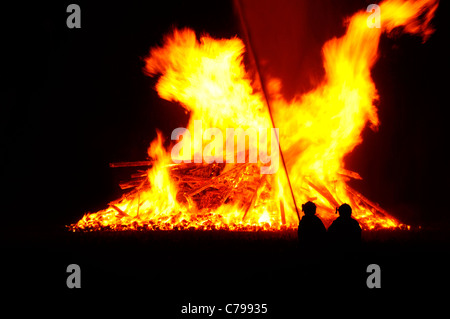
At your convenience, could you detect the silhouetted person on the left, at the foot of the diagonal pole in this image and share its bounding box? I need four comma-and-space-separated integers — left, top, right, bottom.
298, 202, 326, 252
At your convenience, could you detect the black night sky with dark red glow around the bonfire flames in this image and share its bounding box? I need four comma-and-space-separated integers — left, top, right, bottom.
0, 1, 450, 229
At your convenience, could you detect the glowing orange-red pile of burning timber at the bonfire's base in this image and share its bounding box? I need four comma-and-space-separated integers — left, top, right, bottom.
69, 161, 398, 231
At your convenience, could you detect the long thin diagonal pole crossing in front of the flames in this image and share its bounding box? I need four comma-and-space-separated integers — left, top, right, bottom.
234, 0, 300, 222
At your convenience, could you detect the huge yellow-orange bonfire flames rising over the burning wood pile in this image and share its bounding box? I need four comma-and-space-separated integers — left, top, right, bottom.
69, 0, 438, 231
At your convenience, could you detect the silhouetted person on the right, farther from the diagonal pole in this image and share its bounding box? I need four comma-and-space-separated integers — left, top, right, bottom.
328, 204, 361, 252
